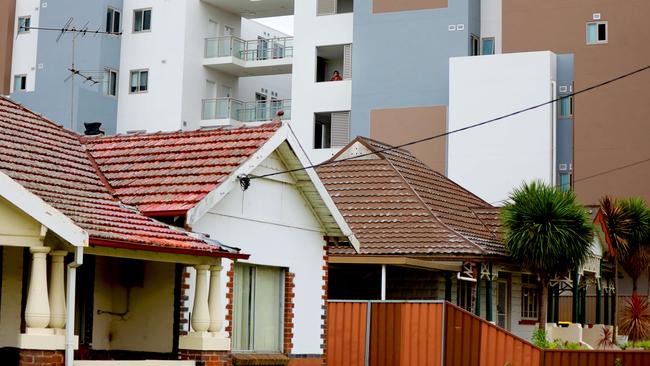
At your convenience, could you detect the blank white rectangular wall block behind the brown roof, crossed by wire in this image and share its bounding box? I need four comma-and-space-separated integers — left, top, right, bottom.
448, 51, 556, 204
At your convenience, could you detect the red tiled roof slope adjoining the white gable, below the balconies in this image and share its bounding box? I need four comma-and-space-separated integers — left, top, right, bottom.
84, 123, 281, 215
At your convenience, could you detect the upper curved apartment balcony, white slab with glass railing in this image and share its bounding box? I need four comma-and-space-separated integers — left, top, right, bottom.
203, 36, 293, 76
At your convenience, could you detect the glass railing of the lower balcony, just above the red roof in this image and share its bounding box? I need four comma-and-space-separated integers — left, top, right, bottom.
201, 98, 291, 122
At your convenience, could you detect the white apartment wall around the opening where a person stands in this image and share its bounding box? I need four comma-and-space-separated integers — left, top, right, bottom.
291, 0, 354, 163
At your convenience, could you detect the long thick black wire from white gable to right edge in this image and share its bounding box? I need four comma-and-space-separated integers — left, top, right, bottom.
244, 65, 650, 181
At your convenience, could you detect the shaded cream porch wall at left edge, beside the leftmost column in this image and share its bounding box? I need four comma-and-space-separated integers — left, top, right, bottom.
0, 247, 24, 348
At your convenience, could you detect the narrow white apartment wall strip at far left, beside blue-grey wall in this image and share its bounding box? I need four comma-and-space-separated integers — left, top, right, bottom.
10, 0, 41, 93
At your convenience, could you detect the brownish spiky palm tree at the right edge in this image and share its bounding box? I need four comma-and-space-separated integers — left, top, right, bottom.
600, 196, 650, 293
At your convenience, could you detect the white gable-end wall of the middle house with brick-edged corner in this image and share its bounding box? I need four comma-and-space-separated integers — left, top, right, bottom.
192, 152, 325, 354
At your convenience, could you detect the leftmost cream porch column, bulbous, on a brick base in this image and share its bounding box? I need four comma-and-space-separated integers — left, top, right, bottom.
25, 247, 50, 328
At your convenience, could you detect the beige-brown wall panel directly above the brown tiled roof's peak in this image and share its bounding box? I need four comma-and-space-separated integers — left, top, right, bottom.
370, 106, 447, 174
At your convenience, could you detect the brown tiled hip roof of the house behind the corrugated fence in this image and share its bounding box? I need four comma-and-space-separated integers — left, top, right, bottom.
317, 138, 505, 256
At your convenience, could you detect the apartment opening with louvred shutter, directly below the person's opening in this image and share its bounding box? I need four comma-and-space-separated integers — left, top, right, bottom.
314, 111, 350, 149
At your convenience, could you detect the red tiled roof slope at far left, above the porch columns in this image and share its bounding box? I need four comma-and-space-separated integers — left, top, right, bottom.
0, 97, 239, 256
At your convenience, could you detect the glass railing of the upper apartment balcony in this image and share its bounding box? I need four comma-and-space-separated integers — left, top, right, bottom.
205, 36, 293, 61
